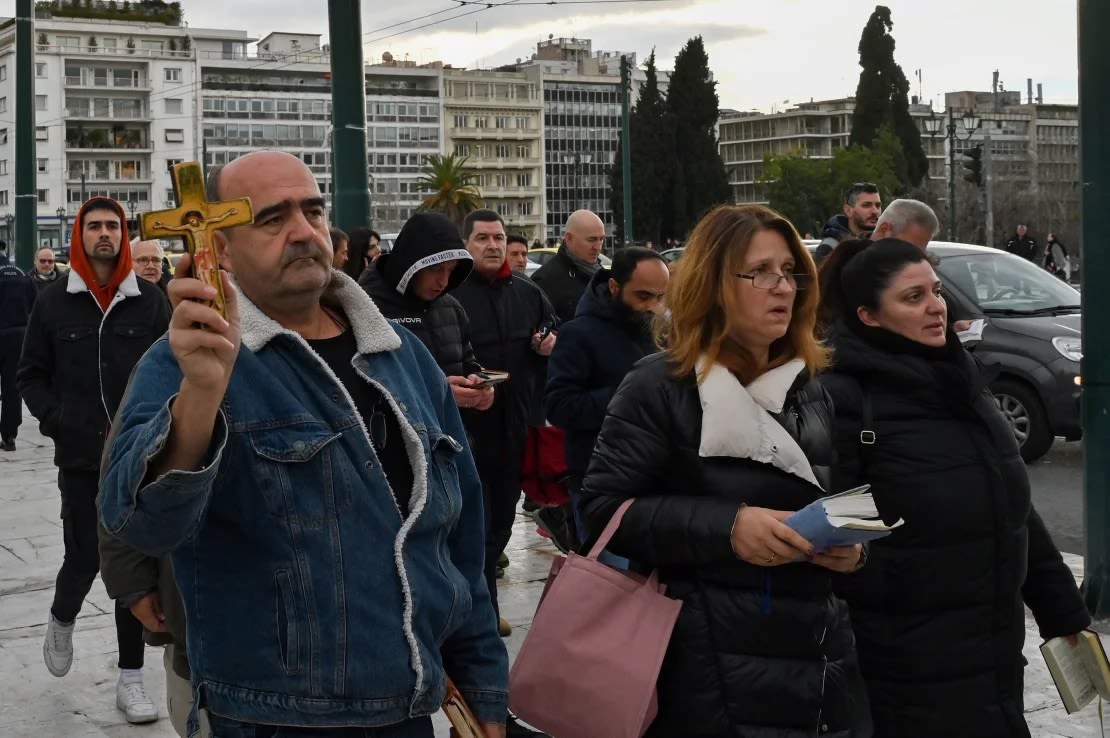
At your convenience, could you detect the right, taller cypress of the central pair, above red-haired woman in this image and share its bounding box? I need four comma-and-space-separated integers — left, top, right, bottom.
662, 36, 731, 237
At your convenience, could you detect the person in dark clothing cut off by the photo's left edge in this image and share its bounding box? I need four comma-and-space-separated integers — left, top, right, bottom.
0, 241, 36, 451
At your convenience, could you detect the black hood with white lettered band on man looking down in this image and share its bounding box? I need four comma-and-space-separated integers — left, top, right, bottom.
380, 213, 474, 294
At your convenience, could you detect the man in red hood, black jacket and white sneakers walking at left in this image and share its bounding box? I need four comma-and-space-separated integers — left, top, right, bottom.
17, 198, 170, 722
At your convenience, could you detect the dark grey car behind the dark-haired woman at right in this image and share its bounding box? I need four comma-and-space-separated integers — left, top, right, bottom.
806, 241, 1083, 462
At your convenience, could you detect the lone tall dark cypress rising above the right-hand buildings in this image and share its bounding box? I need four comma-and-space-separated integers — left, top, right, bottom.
850, 6, 929, 185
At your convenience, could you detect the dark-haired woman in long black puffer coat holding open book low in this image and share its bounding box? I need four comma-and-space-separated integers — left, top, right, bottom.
821, 239, 1090, 738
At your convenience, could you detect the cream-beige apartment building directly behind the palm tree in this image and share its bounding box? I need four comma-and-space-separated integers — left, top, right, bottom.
443, 69, 546, 241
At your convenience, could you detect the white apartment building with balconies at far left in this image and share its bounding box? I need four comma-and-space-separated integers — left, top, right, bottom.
0, 11, 196, 246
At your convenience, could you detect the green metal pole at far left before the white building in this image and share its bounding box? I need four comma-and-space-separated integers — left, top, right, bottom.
11, 0, 39, 267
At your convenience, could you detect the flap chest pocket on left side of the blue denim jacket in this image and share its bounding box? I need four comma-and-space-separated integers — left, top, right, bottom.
248, 423, 341, 527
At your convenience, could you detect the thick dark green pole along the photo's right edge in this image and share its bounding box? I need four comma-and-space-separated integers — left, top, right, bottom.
1079, 0, 1110, 618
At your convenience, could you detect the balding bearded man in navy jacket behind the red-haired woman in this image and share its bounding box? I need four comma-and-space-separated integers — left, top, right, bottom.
544, 246, 670, 538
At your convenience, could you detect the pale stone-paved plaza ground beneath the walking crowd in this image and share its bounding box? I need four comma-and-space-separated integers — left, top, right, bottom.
0, 406, 1101, 738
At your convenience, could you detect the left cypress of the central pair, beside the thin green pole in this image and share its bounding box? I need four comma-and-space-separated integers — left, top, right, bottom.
609, 51, 673, 243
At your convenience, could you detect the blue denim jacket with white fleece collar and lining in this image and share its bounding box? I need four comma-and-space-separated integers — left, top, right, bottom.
99, 273, 508, 727
